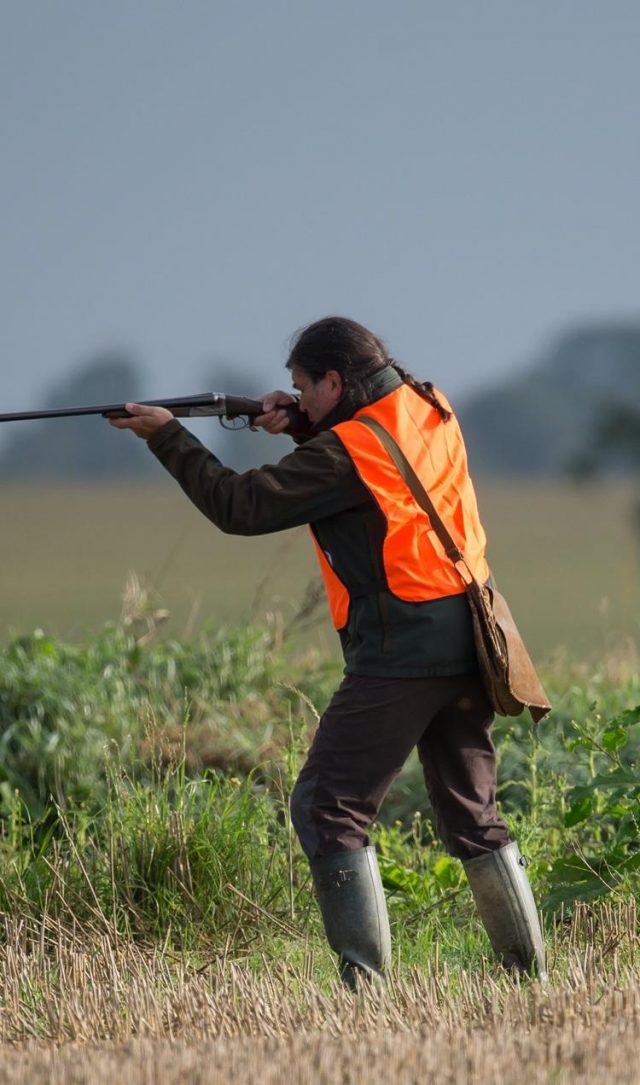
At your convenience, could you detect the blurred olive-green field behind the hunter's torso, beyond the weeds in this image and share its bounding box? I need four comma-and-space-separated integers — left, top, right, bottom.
0, 482, 640, 659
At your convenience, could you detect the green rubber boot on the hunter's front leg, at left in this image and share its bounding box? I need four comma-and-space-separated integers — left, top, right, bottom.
311, 846, 392, 990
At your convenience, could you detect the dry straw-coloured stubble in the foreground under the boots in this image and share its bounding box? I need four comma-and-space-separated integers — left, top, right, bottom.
0, 904, 640, 1085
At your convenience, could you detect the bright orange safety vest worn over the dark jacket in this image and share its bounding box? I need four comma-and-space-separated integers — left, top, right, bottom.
311, 384, 489, 629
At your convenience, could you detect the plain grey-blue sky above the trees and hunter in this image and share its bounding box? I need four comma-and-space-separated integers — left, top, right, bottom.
0, 0, 640, 411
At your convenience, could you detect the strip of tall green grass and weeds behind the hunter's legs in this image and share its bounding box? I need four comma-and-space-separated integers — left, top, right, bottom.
0, 614, 640, 965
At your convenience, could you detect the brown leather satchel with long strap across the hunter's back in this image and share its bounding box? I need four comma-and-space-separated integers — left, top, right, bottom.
356, 414, 551, 723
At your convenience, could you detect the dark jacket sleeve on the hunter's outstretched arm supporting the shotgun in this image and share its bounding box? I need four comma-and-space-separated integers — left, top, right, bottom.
148, 419, 371, 535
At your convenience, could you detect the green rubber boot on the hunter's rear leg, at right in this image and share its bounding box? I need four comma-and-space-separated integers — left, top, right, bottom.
463, 843, 547, 980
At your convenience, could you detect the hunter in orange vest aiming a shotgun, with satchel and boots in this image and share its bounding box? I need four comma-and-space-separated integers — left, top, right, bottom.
0, 317, 549, 990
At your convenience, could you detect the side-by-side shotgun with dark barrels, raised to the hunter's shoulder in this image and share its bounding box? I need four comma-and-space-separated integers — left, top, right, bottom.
0, 392, 310, 437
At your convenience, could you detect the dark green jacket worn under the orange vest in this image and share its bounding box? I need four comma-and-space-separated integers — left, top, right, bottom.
149, 367, 477, 678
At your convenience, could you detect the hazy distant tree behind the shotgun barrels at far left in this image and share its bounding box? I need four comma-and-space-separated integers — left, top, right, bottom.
0, 352, 157, 481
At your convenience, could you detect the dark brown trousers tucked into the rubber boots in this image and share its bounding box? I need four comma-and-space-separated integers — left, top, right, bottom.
291, 675, 510, 859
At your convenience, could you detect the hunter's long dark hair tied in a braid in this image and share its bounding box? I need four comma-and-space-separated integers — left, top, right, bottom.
286, 317, 451, 422
